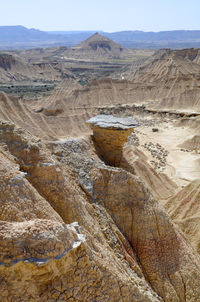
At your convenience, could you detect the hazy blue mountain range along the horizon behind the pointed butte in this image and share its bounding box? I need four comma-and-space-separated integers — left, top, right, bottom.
0, 26, 200, 49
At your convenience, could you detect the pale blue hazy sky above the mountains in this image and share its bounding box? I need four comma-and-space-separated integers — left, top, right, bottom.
0, 0, 200, 32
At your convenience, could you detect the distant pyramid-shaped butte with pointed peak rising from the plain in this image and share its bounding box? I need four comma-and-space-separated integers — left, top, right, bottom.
73, 33, 126, 55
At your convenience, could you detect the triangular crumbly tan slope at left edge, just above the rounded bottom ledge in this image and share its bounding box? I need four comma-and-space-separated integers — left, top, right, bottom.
0, 141, 62, 222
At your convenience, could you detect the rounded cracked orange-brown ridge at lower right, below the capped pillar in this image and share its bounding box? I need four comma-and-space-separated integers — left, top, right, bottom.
93, 168, 200, 302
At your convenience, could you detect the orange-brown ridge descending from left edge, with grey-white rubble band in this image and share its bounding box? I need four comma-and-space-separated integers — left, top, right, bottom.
0, 122, 73, 222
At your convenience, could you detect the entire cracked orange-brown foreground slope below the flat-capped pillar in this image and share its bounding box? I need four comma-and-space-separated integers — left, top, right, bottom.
0, 119, 200, 302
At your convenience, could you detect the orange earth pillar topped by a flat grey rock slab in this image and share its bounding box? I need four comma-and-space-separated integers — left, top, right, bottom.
87, 114, 139, 167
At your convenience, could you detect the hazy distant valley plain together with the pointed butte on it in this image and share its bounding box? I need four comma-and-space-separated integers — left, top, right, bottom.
0, 34, 154, 95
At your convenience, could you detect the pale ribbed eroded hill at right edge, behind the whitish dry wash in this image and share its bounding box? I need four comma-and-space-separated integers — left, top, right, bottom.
113, 49, 200, 112
